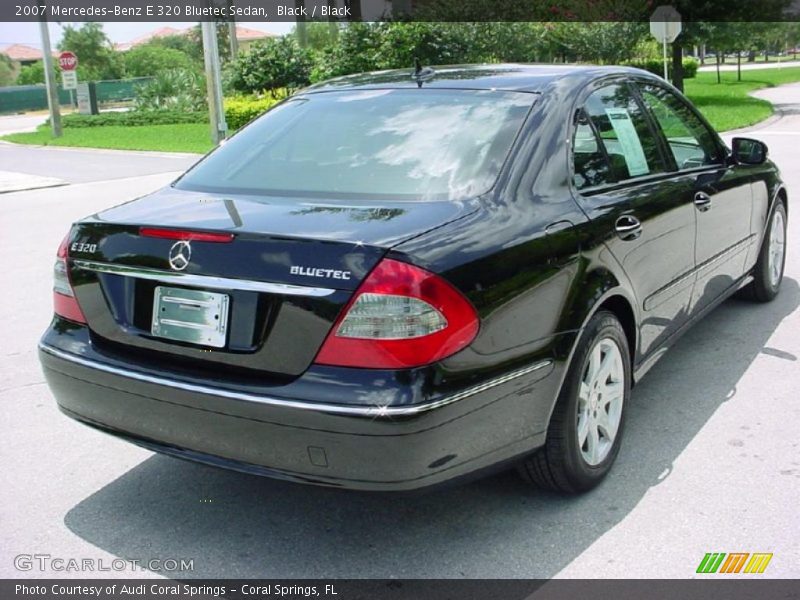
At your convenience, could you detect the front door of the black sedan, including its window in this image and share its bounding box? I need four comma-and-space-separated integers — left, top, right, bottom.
638, 82, 753, 314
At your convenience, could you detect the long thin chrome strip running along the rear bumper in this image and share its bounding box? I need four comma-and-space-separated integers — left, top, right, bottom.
39, 343, 553, 418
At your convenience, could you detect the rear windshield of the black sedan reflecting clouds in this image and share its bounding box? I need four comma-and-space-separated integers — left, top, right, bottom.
176, 89, 536, 200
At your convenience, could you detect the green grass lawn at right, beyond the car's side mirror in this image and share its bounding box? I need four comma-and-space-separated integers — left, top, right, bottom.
686, 67, 800, 131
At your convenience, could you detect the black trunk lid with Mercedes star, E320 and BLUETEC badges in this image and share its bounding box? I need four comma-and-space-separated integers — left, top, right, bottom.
69, 188, 475, 383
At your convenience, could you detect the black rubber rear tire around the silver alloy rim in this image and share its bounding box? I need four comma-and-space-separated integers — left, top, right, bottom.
518, 311, 631, 494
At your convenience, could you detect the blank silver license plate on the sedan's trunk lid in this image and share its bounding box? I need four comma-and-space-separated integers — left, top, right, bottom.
150, 286, 230, 348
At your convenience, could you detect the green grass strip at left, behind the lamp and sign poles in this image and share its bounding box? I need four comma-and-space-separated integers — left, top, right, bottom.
2, 123, 212, 153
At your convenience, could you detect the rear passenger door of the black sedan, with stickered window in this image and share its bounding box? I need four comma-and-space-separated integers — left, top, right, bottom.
573, 80, 695, 356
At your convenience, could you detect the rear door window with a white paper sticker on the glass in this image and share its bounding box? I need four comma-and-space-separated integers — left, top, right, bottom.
584, 84, 665, 181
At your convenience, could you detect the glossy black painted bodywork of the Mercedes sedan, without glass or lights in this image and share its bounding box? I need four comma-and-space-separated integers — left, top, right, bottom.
40, 65, 785, 489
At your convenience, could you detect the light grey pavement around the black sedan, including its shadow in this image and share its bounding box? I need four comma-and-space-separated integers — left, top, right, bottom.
0, 86, 800, 578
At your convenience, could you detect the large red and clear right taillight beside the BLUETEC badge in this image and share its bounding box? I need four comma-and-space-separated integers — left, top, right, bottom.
315, 259, 478, 369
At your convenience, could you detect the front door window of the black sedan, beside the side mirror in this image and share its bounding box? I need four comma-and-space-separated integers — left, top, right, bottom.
641, 85, 719, 170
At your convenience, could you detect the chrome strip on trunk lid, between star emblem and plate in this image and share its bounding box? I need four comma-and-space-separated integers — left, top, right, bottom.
72, 260, 336, 298
